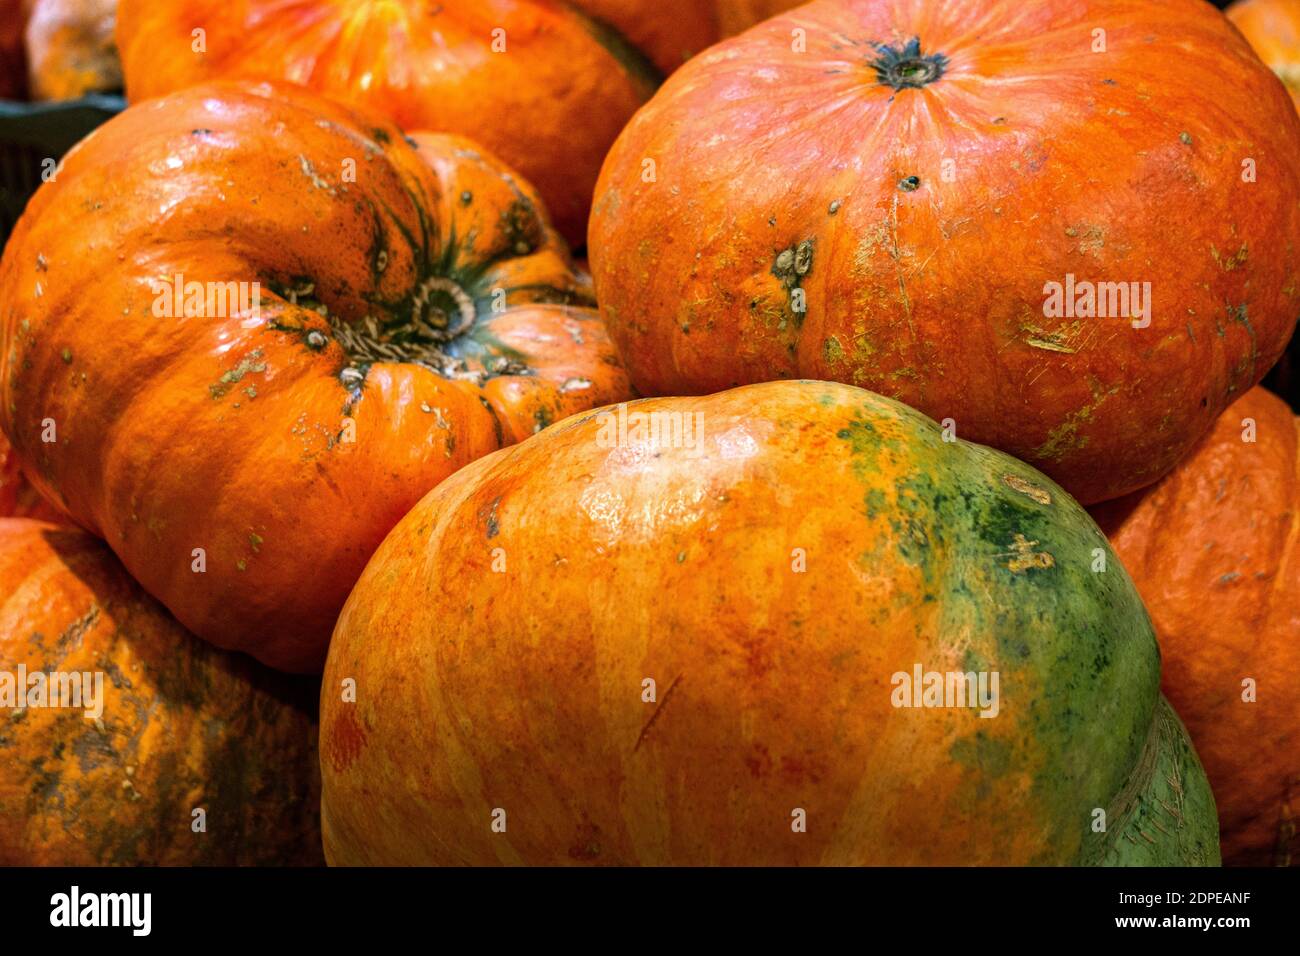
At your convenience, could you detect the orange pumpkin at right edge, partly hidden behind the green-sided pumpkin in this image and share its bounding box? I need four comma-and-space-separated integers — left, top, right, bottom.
1096, 389, 1300, 866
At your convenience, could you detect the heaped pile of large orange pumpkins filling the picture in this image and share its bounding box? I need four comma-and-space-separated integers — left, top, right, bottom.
0, 0, 1300, 865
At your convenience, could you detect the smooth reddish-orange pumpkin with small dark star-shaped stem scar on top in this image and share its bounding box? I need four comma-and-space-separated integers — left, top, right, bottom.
589, 0, 1300, 502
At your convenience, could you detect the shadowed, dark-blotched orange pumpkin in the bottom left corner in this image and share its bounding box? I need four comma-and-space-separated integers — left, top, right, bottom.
0, 518, 321, 866
